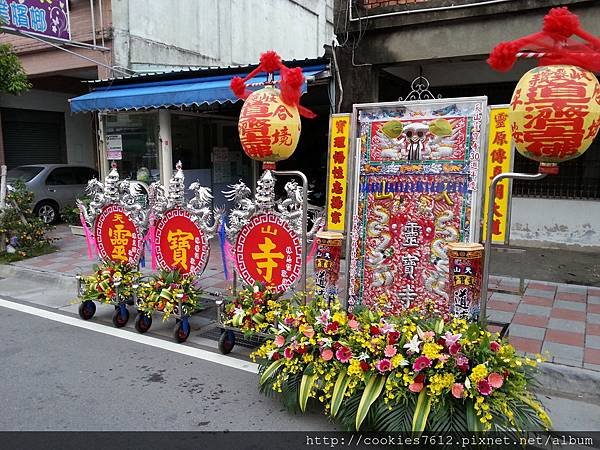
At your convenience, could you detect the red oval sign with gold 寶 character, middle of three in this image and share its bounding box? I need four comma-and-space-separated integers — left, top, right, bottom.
154, 208, 210, 274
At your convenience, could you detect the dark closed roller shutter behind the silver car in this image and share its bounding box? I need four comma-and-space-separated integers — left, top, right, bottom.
2, 108, 67, 169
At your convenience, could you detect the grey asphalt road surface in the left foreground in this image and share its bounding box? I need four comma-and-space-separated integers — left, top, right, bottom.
0, 307, 335, 431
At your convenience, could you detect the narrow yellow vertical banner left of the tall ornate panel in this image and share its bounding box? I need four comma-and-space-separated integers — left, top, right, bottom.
326, 114, 350, 231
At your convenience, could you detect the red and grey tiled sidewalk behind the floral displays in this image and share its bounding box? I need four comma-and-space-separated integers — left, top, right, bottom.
14, 225, 600, 371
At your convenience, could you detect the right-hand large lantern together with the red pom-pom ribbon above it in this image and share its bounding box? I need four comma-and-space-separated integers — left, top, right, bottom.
488, 7, 600, 173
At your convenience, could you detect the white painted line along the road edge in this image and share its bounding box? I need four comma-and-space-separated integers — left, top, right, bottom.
0, 297, 258, 373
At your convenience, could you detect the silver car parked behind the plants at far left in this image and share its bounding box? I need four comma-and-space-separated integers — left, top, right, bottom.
6, 164, 98, 223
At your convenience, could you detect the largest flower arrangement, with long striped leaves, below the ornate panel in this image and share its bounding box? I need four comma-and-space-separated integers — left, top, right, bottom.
252, 298, 551, 433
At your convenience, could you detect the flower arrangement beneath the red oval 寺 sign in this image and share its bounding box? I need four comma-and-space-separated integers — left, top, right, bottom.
223, 283, 283, 333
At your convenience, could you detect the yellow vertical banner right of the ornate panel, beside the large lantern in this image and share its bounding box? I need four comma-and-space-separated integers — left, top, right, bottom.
483, 106, 514, 245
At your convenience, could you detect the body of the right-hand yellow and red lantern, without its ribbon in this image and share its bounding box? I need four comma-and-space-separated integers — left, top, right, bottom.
509, 65, 600, 173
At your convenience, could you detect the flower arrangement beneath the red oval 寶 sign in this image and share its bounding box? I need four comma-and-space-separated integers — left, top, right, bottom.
138, 270, 202, 321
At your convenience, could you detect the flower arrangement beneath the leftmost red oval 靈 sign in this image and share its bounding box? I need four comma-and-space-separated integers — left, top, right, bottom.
80, 262, 141, 303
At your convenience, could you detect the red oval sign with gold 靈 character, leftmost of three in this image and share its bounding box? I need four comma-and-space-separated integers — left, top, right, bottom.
94, 204, 142, 265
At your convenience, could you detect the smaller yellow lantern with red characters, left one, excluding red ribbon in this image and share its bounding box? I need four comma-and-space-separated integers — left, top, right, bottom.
238, 86, 300, 162
